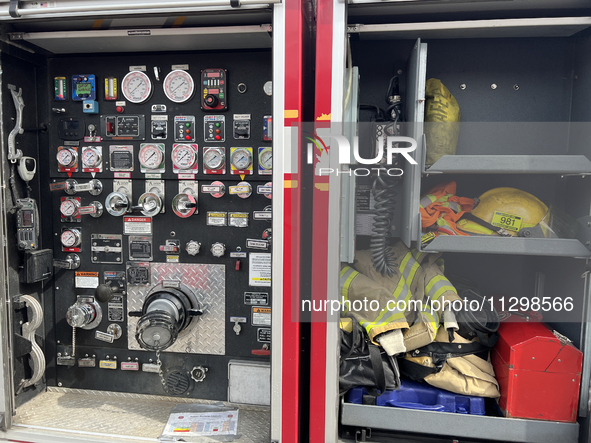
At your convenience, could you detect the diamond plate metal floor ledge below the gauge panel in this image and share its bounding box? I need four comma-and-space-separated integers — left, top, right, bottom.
13, 388, 271, 443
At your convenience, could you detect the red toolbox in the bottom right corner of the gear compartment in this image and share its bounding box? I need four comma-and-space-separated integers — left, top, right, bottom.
492, 322, 583, 423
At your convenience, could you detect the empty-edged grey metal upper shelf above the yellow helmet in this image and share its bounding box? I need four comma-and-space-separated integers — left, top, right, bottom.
423, 155, 591, 174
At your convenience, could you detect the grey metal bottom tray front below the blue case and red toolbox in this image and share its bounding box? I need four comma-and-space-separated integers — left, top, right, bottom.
341, 403, 579, 443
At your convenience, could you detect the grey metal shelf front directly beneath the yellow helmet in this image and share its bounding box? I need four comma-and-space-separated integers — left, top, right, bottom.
421, 235, 591, 258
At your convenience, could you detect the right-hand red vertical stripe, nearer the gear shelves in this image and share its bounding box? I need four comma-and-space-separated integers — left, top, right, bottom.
310, 0, 334, 443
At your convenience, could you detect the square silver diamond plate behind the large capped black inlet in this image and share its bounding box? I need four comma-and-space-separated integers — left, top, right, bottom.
127, 263, 226, 355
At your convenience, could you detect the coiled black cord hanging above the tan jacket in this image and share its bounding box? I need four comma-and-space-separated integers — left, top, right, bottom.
369, 175, 398, 277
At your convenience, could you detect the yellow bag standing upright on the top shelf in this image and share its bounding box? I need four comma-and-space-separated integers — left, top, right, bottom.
425, 78, 461, 165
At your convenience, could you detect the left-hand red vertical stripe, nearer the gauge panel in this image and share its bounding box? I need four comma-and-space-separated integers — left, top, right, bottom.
281, 0, 304, 442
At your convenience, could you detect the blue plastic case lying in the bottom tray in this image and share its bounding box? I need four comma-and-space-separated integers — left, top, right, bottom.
347, 380, 485, 415
